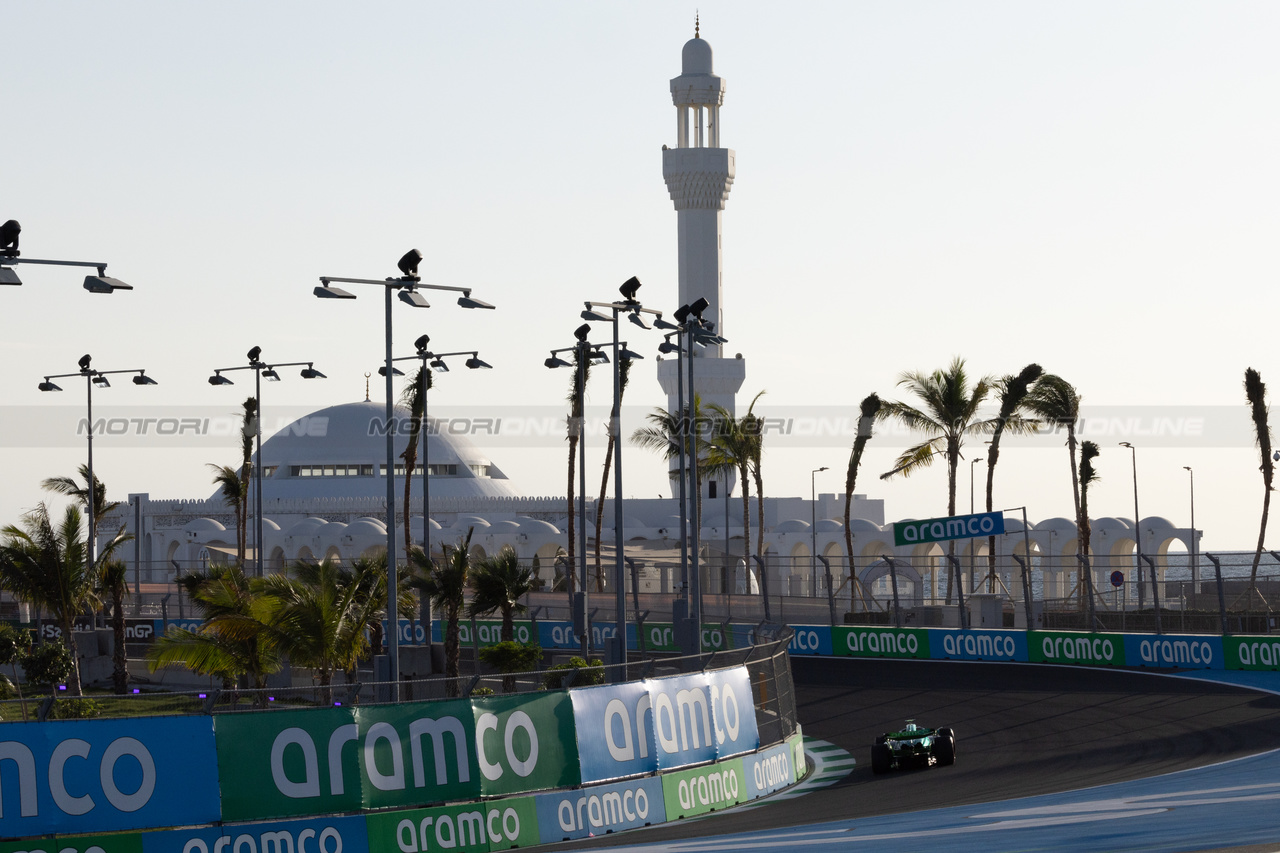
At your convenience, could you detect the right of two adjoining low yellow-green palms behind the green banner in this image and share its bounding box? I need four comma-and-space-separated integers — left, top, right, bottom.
265, 560, 376, 704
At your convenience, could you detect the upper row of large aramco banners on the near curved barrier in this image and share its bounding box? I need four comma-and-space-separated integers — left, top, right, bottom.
0, 666, 759, 835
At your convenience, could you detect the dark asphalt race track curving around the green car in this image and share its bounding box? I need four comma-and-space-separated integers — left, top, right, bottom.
558, 657, 1280, 848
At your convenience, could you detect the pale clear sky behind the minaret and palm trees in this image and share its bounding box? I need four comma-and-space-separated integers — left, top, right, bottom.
0, 0, 1280, 549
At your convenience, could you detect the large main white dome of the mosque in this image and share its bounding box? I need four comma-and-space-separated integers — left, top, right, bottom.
214, 400, 520, 501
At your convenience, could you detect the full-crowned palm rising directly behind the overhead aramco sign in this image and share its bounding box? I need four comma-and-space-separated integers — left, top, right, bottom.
879, 356, 993, 603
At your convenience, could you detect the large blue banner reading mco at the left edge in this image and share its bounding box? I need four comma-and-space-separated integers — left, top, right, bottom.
0, 717, 221, 838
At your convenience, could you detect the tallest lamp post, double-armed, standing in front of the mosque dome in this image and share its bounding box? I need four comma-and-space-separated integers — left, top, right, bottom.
312, 248, 493, 702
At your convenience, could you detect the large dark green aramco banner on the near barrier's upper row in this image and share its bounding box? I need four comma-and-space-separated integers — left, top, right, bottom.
214, 692, 580, 821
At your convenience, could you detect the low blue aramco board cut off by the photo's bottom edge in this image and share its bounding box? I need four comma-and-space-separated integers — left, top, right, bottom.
142, 817, 369, 853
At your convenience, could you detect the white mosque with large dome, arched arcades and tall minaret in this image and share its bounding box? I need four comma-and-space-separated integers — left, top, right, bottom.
101, 26, 1194, 603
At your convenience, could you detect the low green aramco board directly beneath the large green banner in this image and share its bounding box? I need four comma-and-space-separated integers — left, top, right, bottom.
365, 797, 540, 853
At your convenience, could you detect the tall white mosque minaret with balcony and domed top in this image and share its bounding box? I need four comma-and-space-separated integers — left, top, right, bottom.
658, 18, 746, 497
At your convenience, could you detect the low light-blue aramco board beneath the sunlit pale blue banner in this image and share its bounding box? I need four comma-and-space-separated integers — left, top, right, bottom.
532, 776, 667, 853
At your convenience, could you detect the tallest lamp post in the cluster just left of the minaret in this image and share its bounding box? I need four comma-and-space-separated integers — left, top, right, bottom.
582, 275, 676, 680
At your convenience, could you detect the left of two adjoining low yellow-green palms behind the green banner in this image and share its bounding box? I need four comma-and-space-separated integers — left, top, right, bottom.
147, 566, 283, 707
